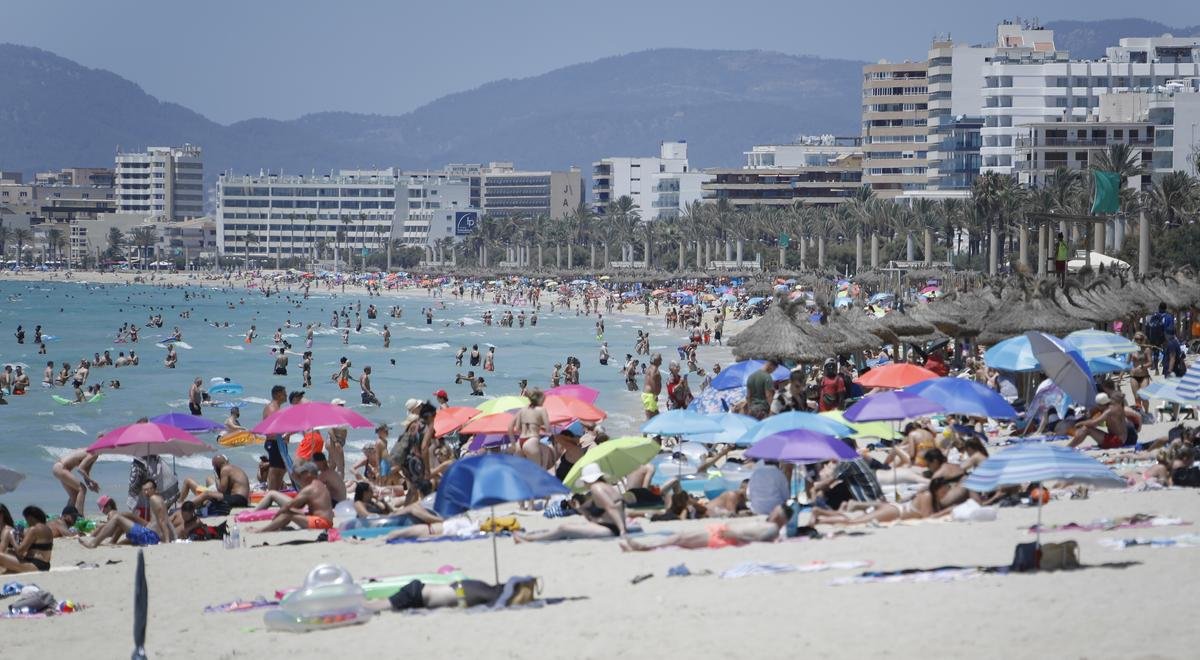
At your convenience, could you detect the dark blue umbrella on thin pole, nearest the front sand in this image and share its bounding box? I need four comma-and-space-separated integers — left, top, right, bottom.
433, 454, 570, 584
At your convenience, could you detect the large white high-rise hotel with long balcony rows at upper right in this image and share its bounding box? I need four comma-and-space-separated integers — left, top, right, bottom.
980, 25, 1200, 174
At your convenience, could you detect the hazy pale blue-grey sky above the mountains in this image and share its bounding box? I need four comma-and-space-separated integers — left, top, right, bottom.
0, 0, 1200, 122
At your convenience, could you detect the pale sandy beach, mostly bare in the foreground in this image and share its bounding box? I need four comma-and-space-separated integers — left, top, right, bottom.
0, 274, 1200, 659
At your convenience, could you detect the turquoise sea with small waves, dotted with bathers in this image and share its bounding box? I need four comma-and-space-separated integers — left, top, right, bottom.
0, 281, 678, 514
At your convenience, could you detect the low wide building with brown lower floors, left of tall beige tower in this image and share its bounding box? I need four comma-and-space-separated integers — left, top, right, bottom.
703, 136, 863, 208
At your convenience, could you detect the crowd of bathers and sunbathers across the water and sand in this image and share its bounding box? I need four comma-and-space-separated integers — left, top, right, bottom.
0, 271, 1200, 572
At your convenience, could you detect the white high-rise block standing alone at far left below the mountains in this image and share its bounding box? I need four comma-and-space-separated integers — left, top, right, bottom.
115, 144, 204, 220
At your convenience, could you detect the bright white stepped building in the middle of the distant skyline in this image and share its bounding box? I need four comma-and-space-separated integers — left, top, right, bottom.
592, 140, 712, 221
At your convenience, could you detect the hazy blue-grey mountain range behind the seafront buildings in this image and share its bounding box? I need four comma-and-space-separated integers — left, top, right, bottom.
0, 19, 1200, 180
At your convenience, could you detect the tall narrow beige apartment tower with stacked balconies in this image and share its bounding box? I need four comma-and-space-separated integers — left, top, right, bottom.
863, 61, 929, 198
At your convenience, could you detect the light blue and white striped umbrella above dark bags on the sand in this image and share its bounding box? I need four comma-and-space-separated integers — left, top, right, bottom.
962, 443, 1127, 545
